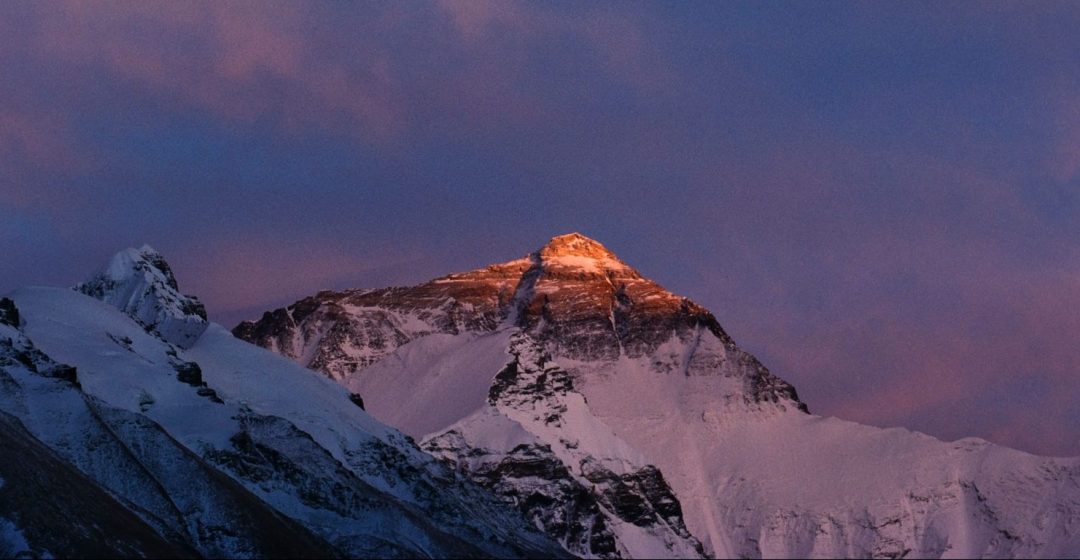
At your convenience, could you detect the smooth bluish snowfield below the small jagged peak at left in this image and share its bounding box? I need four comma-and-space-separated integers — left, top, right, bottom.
13, 288, 406, 487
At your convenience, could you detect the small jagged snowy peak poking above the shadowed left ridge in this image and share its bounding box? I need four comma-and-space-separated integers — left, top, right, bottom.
75, 245, 208, 349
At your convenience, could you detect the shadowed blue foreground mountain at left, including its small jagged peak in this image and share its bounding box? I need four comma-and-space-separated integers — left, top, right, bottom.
0, 247, 566, 558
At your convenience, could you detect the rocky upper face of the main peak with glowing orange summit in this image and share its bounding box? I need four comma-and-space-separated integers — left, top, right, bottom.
233, 233, 805, 408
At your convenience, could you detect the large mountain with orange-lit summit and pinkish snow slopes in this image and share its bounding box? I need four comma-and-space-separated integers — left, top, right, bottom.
233, 234, 1080, 558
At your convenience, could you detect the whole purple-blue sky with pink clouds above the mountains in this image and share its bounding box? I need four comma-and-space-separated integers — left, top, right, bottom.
0, 0, 1080, 454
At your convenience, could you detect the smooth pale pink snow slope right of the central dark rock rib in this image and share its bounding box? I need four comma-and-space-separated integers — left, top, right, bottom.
570, 349, 1080, 558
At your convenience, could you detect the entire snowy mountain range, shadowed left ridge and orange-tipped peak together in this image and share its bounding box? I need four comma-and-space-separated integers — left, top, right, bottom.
0, 234, 1080, 558
